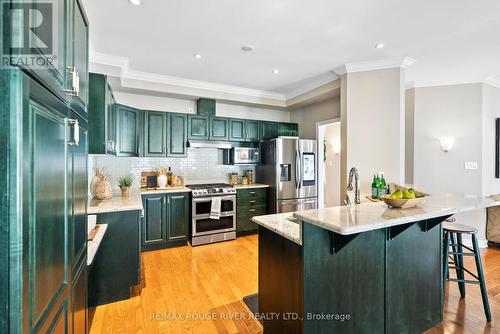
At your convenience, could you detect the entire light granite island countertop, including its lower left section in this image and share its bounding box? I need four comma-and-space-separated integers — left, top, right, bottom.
252, 194, 500, 244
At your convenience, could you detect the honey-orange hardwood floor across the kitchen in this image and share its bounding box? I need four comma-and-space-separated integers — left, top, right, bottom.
90, 235, 500, 334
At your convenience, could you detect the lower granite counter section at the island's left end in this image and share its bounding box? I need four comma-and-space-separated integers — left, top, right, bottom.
252, 212, 302, 245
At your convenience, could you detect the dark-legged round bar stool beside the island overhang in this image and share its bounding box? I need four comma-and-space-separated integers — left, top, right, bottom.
443, 218, 491, 322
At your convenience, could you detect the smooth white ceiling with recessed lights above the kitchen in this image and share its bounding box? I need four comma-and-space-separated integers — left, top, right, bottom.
84, 0, 500, 95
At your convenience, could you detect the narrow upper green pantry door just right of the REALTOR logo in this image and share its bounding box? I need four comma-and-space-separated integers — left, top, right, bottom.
67, 0, 89, 117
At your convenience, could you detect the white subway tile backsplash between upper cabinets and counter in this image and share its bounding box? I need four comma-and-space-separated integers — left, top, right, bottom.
88, 148, 255, 191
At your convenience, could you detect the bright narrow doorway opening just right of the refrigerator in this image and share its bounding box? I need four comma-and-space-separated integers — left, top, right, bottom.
316, 119, 342, 209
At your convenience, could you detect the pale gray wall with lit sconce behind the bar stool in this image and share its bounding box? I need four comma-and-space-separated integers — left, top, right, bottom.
407, 83, 490, 241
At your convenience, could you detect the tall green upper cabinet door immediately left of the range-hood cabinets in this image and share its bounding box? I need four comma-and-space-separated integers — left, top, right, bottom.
167, 113, 187, 157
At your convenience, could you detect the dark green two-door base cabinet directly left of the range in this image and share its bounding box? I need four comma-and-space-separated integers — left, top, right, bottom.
142, 192, 189, 250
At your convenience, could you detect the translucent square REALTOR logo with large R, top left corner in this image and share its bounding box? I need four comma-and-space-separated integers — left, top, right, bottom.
1, 0, 57, 68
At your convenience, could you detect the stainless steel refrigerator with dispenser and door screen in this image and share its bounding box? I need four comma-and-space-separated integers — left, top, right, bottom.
256, 137, 318, 213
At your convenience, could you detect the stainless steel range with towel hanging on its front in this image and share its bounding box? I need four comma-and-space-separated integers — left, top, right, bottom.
186, 183, 236, 246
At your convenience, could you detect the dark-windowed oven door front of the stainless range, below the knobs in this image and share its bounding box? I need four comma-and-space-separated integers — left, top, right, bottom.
192, 195, 236, 237
